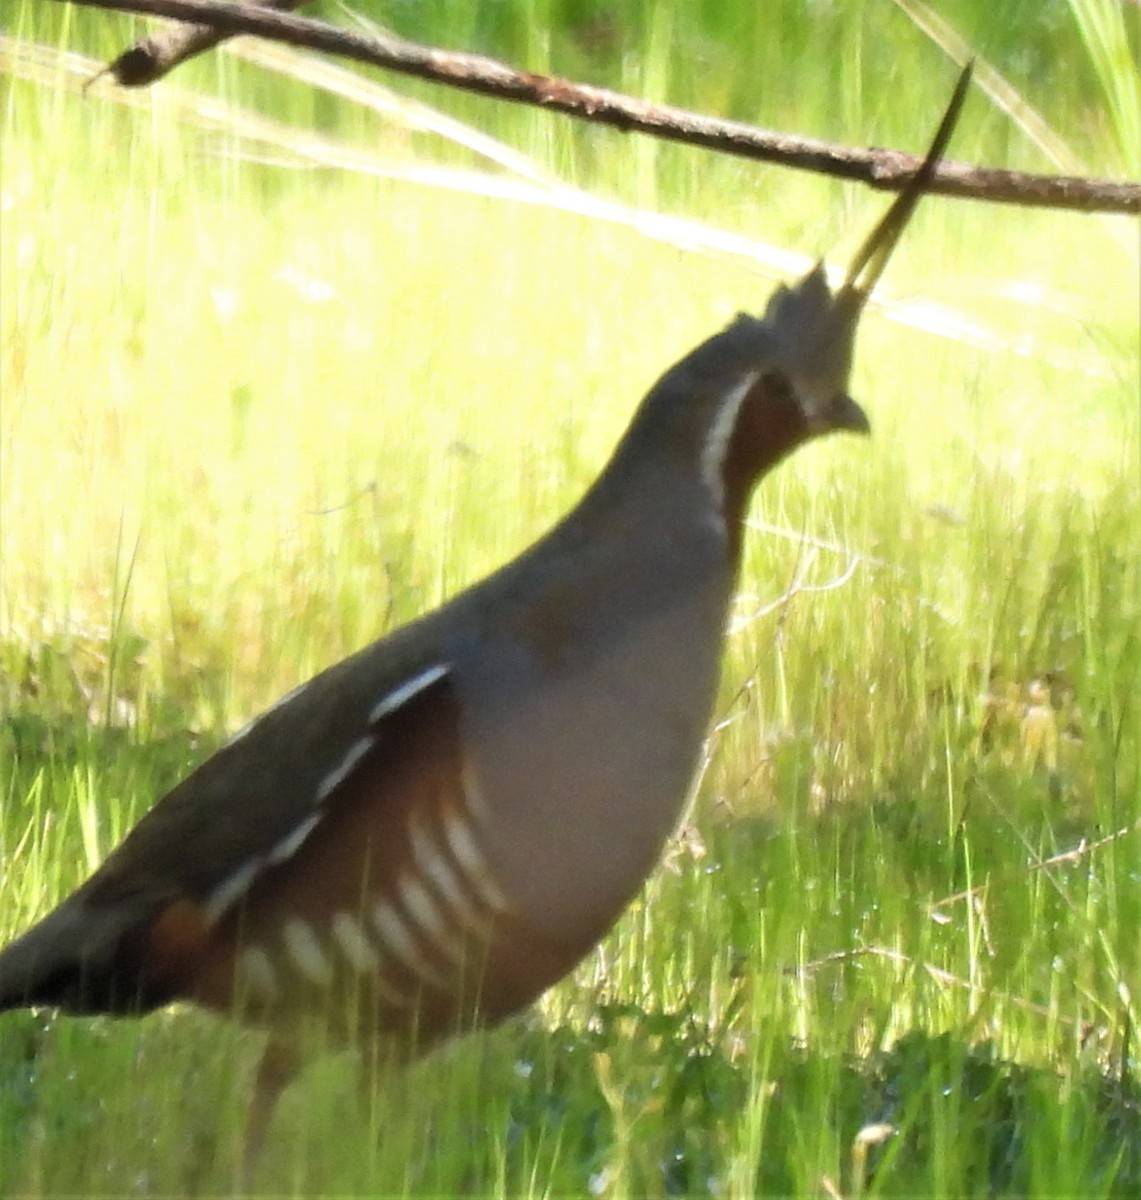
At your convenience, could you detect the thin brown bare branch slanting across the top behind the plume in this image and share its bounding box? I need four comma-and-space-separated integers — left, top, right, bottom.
69, 0, 1141, 212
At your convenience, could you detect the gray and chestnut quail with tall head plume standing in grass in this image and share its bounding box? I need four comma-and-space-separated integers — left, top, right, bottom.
0, 65, 971, 1164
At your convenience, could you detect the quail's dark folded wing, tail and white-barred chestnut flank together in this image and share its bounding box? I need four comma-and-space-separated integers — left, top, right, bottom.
0, 660, 506, 1015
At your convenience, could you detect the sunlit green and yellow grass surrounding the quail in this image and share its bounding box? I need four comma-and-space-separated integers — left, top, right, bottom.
0, 4, 1141, 1196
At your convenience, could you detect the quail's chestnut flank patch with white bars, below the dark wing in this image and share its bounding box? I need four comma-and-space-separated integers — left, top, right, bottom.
133, 665, 523, 1025
